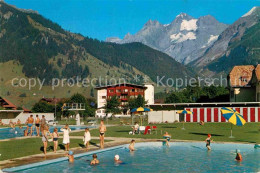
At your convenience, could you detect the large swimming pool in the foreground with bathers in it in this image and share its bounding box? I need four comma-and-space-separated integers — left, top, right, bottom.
4, 142, 260, 173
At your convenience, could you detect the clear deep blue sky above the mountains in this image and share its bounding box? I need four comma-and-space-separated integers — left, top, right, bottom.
5, 0, 260, 40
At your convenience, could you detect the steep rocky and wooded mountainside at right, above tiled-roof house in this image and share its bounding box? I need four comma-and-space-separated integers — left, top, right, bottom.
190, 7, 260, 76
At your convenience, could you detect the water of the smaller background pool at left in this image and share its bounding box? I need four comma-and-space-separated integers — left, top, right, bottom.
0, 126, 91, 139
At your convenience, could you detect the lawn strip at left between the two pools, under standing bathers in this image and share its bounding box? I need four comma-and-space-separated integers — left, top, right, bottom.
0, 138, 106, 161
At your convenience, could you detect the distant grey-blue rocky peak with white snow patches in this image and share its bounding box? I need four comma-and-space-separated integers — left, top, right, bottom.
107, 13, 227, 64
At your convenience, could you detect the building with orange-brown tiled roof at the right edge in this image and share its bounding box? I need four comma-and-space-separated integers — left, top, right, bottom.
228, 64, 260, 102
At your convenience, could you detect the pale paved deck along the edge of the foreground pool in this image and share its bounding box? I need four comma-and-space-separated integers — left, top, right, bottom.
0, 136, 256, 170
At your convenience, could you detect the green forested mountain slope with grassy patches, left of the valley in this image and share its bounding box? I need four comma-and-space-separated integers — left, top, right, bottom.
0, 2, 192, 84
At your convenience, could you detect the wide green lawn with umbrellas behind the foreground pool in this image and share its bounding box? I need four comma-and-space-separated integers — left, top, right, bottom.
70, 123, 260, 143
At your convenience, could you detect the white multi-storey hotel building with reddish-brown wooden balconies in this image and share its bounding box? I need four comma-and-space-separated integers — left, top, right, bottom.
95, 83, 154, 108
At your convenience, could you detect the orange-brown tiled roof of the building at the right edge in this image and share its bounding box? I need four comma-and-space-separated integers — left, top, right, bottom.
229, 65, 255, 87
